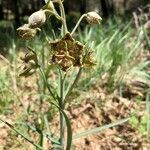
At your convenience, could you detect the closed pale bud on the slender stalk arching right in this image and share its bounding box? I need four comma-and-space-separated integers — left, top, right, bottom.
86, 11, 102, 24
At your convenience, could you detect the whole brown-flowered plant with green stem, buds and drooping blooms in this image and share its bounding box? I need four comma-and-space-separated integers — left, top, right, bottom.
2, 0, 101, 150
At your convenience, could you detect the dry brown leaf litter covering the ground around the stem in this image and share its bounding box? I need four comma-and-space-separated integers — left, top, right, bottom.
0, 67, 150, 150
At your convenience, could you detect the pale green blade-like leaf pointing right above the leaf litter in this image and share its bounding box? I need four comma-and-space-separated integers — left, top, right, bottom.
73, 117, 130, 140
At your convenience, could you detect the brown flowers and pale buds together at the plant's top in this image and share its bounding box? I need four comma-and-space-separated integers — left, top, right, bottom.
17, 0, 102, 76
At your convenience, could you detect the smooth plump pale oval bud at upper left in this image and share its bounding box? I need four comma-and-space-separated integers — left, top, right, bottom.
28, 10, 46, 28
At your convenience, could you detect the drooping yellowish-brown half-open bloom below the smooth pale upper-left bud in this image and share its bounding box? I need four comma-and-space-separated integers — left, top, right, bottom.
17, 24, 37, 40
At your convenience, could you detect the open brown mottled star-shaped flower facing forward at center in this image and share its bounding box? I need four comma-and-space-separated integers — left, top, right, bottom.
50, 33, 84, 71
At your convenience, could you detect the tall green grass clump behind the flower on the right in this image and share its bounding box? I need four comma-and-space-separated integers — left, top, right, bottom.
79, 20, 150, 92
